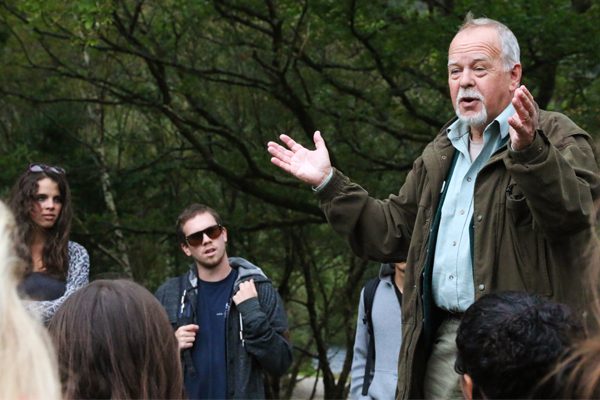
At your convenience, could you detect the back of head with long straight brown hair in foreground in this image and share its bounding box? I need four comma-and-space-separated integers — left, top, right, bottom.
49, 280, 184, 399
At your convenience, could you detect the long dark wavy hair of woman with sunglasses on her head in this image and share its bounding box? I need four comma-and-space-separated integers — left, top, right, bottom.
9, 168, 73, 279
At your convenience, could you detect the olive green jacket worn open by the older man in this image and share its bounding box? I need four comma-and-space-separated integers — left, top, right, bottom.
318, 111, 600, 399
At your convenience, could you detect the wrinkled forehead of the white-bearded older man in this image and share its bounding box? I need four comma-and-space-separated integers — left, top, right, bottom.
448, 26, 502, 64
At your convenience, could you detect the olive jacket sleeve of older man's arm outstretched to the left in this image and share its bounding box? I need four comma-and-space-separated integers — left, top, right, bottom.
318, 163, 423, 262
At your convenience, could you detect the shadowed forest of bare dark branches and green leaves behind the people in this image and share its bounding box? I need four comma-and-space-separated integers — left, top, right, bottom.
0, 0, 600, 398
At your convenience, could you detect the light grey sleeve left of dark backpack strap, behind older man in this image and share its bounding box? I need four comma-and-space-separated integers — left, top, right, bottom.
349, 288, 369, 399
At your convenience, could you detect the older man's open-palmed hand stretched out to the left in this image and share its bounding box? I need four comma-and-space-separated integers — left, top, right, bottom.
267, 131, 331, 187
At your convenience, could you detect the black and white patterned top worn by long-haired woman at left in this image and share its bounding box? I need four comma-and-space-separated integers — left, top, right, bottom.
27, 241, 90, 324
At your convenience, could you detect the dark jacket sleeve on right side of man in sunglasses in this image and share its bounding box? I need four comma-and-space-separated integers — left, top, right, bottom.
237, 283, 292, 376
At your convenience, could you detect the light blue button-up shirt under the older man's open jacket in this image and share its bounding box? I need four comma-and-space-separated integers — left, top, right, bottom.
432, 104, 515, 312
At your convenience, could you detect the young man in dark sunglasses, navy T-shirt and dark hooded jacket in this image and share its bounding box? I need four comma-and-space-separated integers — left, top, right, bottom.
156, 204, 292, 399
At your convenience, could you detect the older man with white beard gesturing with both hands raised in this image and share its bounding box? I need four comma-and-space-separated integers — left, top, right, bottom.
268, 16, 600, 399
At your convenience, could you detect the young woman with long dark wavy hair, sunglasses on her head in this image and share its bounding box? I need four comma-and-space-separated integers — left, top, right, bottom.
10, 164, 90, 323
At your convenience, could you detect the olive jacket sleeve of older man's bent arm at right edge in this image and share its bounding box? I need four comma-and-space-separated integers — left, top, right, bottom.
505, 113, 600, 239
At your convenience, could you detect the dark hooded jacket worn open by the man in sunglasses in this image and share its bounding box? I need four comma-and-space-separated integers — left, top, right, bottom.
155, 257, 292, 399
